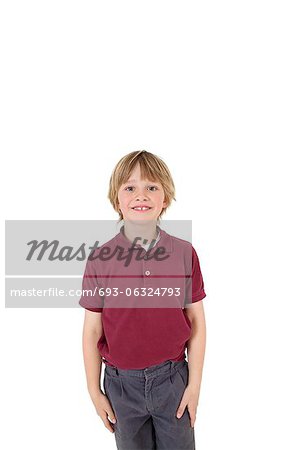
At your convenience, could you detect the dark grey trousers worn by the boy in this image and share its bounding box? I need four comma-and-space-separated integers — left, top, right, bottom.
104, 359, 195, 450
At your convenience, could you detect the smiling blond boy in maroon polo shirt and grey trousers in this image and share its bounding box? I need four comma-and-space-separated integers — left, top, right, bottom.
79, 151, 206, 450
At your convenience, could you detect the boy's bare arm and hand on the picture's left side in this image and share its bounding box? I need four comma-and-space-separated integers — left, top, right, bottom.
82, 309, 116, 433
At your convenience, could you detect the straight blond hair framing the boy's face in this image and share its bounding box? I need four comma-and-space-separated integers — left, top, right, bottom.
108, 150, 176, 222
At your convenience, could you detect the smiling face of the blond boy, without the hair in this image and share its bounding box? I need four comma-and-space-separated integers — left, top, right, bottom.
118, 163, 167, 220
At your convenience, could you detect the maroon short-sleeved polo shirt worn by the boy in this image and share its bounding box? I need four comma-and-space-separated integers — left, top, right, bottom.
79, 227, 206, 369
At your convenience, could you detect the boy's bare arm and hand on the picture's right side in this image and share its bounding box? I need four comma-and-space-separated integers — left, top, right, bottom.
177, 300, 206, 427
